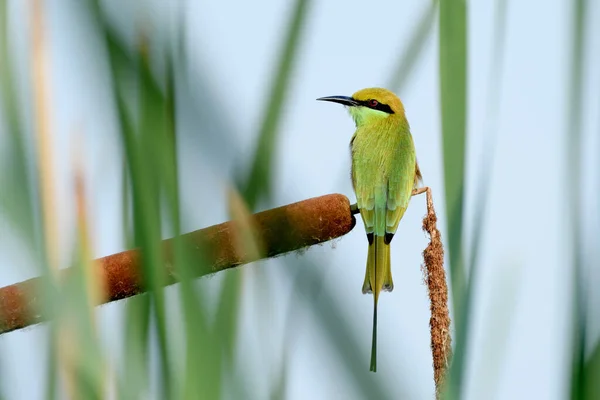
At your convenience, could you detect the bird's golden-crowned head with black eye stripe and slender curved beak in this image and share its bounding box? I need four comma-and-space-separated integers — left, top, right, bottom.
317, 88, 405, 126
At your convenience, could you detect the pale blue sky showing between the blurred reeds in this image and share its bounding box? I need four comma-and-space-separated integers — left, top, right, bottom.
0, 0, 600, 399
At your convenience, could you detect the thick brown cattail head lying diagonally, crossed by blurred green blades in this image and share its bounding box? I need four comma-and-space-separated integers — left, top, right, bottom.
0, 194, 356, 334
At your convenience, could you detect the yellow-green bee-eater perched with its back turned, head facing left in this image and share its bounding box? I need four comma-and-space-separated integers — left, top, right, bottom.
317, 88, 421, 372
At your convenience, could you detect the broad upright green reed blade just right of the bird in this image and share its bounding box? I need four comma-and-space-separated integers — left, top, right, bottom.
439, 0, 468, 398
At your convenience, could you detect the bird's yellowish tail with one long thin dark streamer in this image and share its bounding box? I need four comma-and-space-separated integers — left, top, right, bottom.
363, 236, 394, 372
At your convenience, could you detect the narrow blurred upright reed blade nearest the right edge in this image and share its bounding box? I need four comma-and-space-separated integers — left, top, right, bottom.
561, 0, 591, 399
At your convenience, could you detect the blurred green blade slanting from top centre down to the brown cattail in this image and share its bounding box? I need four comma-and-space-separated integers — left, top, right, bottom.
242, 0, 311, 211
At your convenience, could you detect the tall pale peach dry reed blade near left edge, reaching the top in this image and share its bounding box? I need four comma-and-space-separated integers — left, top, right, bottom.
26, 0, 71, 399
